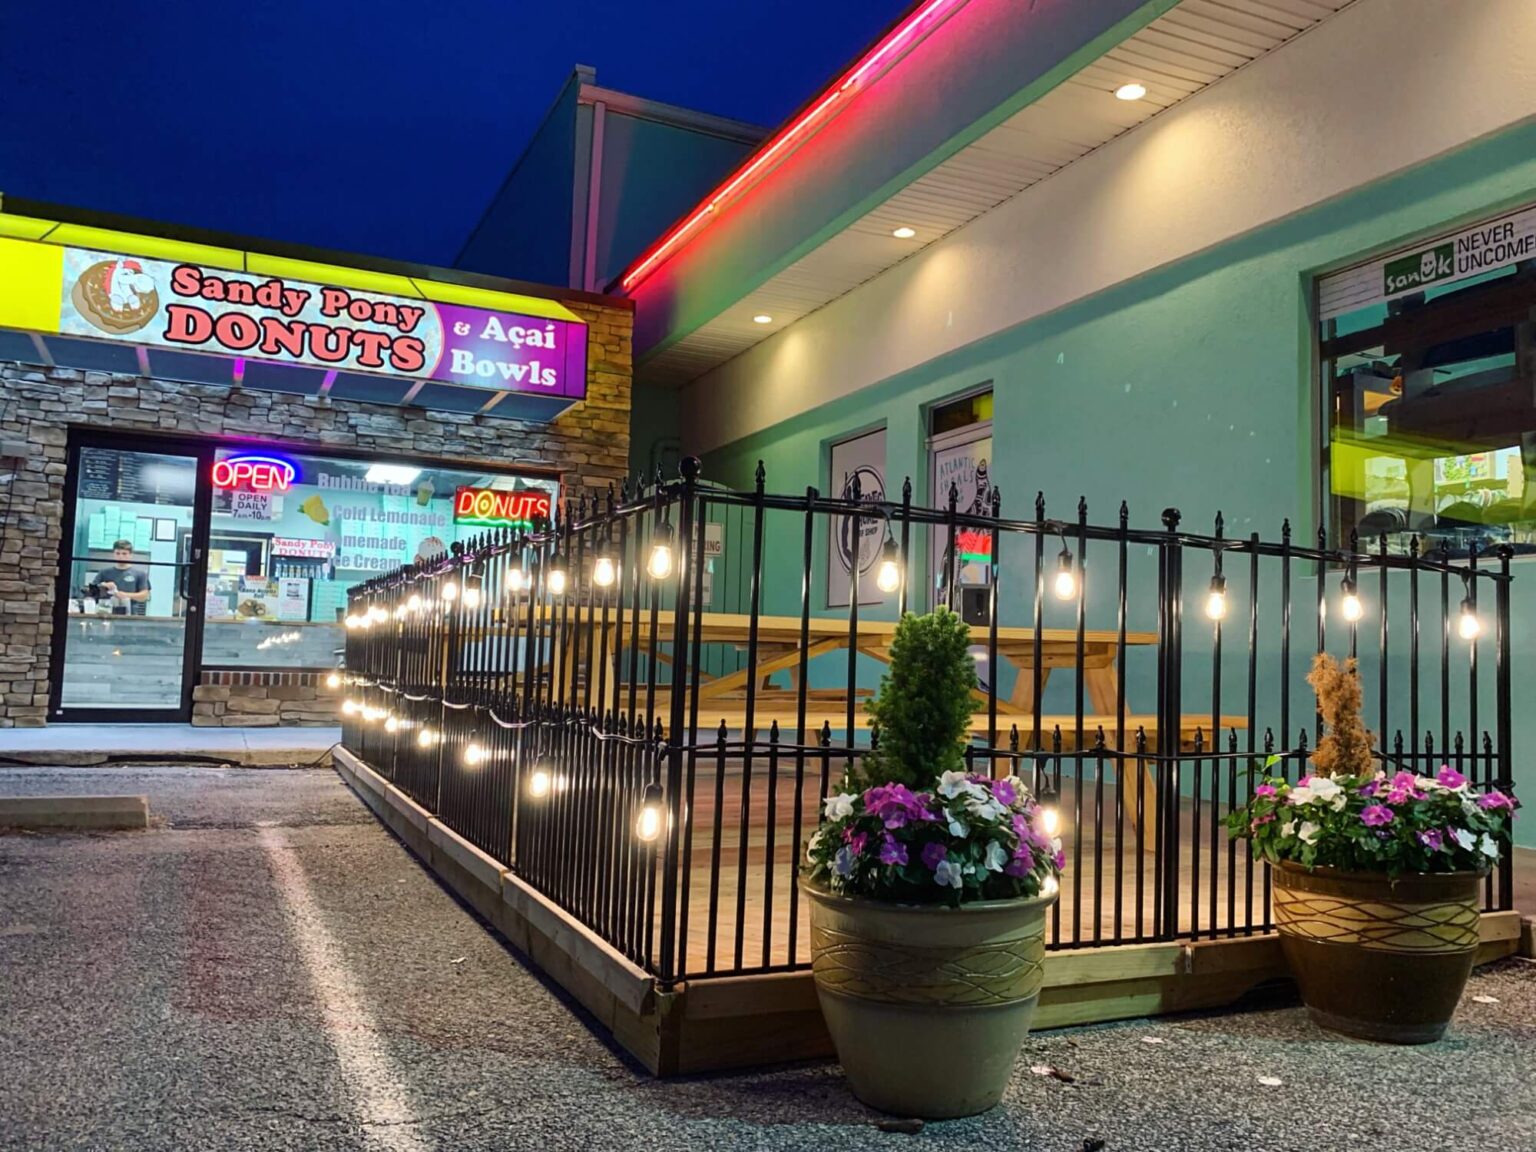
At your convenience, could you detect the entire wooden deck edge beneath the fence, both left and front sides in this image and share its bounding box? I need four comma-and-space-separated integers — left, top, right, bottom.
333, 748, 1522, 1077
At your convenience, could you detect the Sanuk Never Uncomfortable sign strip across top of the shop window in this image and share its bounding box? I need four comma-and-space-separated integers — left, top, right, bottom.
1318, 207, 1536, 319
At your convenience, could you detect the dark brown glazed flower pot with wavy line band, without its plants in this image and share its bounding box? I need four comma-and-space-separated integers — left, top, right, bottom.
1273, 863, 1482, 1044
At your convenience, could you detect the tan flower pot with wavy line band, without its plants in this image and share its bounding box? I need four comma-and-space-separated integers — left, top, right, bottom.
802, 883, 1055, 1120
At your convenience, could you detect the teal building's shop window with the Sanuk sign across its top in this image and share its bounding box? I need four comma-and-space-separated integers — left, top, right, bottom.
1319, 209, 1536, 565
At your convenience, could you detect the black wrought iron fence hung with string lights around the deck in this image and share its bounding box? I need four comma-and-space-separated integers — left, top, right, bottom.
341, 461, 1511, 982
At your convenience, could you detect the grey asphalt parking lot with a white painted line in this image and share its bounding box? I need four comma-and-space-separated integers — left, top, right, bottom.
0, 766, 1536, 1152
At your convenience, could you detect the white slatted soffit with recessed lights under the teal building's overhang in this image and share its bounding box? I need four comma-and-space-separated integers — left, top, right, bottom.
639, 0, 1352, 387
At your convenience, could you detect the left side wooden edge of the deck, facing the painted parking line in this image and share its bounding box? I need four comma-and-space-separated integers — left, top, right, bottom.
333, 748, 663, 1075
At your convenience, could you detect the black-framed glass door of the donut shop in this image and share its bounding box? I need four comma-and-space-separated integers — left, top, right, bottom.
49, 441, 209, 722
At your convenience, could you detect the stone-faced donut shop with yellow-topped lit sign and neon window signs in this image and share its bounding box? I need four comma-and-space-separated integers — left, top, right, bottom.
0, 200, 631, 727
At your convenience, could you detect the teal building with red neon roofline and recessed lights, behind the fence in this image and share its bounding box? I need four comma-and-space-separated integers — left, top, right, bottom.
619, 0, 1536, 845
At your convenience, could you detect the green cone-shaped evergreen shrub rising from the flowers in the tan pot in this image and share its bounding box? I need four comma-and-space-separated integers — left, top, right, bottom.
854, 607, 978, 788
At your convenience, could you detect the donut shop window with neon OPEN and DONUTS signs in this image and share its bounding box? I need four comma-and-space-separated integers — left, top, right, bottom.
203, 449, 558, 668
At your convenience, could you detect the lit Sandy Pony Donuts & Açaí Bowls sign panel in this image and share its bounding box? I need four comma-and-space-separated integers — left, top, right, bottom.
58, 247, 587, 399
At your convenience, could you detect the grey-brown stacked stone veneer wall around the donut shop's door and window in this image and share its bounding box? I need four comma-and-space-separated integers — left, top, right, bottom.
0, 300, 633, 728
